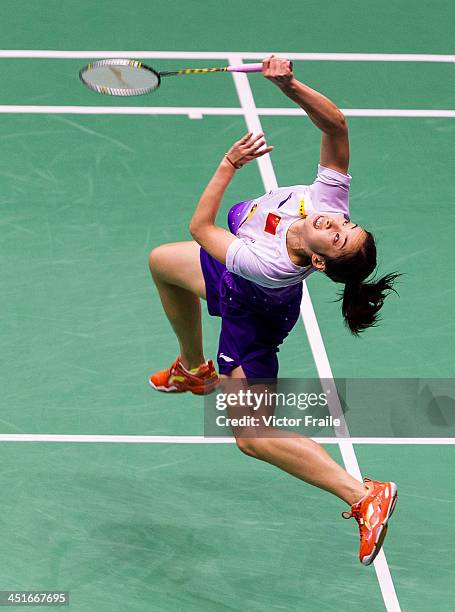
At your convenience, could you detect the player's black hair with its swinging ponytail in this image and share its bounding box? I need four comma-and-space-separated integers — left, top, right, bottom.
325, 231, 400, 335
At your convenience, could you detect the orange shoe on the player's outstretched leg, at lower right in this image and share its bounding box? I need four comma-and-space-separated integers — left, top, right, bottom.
341, 478, 397, 565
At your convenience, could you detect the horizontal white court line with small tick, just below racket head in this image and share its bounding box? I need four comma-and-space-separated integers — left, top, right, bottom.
0, 104, 455, 119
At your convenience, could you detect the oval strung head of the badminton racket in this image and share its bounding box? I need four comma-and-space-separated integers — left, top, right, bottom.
79, 59, 161, 96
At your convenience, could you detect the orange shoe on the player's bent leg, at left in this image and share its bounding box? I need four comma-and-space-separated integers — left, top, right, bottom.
149, 357, 220, 395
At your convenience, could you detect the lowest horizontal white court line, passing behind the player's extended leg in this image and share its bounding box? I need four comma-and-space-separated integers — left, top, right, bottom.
0, 433, 455, 446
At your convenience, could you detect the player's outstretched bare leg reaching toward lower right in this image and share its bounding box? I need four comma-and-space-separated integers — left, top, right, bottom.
223, 367, 367, 505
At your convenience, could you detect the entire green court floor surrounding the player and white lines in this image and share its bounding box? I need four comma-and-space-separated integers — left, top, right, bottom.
0, 0, 455, 612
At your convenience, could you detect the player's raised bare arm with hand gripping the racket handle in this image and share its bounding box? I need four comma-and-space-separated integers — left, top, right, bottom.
262, 55, 349, 174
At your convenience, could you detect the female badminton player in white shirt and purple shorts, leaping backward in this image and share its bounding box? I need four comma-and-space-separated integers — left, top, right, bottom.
150, 55, 397, 565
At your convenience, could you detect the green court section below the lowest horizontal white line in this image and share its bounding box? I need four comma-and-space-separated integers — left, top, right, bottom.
1, 443, 455, 612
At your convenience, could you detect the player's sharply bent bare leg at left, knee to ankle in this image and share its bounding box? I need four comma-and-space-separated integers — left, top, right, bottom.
149, 241, 205, 369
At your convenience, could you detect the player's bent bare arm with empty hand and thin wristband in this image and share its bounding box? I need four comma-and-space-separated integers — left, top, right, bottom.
190, 132, 273, 264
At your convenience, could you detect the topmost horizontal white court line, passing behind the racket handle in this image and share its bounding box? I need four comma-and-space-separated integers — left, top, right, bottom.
0, 49, 455, 63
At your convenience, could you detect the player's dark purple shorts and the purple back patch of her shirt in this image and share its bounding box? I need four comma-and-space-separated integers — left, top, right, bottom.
200, 200, 302, 381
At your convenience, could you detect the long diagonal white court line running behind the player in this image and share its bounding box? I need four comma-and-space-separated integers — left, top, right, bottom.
229, 53, 400, 612
